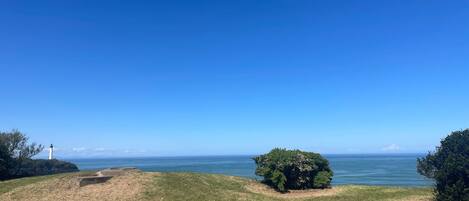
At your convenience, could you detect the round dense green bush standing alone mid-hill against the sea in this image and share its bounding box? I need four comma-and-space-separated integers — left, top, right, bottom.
254, 148, 333, 192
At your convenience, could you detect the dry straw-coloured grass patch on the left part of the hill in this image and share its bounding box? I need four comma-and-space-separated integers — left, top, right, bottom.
0, 171, 149, 201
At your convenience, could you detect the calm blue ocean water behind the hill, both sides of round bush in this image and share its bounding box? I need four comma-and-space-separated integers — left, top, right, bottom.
68, 154, 433, 186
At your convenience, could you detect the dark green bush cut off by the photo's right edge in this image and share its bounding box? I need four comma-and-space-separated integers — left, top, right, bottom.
417, 129, 469, 201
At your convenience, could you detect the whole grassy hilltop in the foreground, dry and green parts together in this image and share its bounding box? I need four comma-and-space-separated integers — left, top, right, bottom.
0, 172, 432, 201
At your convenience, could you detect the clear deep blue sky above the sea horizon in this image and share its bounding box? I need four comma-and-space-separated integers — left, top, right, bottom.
0, 0, 469, 157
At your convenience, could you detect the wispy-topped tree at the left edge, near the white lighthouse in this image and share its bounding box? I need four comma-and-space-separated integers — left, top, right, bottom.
0, 130, 44, 180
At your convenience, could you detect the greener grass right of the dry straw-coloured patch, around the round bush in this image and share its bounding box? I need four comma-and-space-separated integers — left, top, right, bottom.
144, 173, 432, 201
